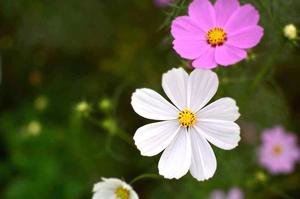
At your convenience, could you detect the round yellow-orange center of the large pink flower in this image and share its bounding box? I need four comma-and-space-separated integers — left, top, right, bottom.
207, 27, 227, 47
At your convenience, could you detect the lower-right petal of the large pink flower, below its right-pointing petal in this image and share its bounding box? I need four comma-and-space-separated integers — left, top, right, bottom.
216, 45, 247, 66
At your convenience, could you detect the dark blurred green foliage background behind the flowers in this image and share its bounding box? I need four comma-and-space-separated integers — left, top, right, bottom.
0, 0, 300, 199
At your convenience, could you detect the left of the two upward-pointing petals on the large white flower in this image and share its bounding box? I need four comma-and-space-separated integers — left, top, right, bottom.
162, 68, 189, 110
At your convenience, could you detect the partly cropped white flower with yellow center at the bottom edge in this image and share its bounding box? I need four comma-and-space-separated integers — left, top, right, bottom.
92, 178, 139, 199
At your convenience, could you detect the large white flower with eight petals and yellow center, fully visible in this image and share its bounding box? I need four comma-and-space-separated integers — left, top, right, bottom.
131, 68, 240, 181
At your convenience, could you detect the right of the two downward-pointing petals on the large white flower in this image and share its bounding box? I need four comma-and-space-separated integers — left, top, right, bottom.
188, 127, 217, 181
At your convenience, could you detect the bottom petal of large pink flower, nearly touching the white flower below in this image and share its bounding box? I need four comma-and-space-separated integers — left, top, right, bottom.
192, 45, 217, 69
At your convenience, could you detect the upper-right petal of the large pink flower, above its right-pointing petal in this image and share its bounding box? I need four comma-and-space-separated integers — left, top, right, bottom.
224, 4, 259, 34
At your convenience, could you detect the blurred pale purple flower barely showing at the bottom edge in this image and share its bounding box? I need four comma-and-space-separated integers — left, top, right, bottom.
209, 187, 244, 199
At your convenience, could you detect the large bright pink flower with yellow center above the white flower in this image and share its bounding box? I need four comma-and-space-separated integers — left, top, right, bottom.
171, 0, 263, 69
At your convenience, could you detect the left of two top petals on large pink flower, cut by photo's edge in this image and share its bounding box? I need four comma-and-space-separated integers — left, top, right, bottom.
188, 0, 216, 32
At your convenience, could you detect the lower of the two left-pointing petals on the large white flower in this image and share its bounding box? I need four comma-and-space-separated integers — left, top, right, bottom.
133, 120, 180, 156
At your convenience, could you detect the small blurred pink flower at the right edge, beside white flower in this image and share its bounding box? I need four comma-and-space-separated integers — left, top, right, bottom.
259, 126, 300, 174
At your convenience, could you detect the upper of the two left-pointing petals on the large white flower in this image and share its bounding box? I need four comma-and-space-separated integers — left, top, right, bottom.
131, 88, 178, 120
